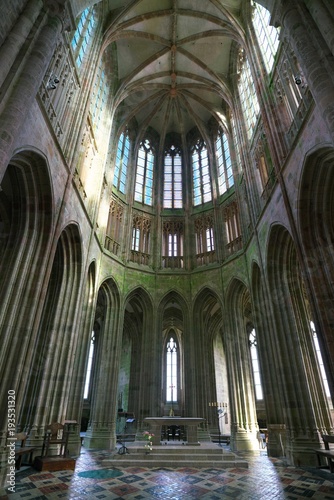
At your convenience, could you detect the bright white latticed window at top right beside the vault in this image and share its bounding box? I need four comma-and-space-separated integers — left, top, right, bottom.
252, 2, 279, 73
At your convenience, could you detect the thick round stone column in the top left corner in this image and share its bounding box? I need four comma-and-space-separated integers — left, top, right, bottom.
0, 0, 66, 181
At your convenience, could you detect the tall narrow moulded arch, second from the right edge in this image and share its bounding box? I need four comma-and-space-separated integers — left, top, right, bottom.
267, 224, 331, 463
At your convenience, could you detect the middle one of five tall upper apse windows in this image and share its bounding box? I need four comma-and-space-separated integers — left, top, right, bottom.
164, 145, 182, 208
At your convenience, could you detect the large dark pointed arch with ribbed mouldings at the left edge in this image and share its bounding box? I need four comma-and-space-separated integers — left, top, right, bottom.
0, 150, 54, 434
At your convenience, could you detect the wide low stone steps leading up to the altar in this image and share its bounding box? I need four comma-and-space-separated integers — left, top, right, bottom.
103, 441, 248, 469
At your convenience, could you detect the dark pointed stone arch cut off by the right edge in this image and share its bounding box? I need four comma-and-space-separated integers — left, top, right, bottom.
297, 146, 334, 401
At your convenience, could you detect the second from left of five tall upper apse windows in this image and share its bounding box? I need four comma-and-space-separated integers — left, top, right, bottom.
135, 140, 154, 205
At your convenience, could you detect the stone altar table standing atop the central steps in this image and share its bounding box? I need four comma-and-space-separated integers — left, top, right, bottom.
144, 417, 205, 446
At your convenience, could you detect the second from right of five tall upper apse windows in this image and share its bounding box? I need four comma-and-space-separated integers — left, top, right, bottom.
191, 139, 212, 206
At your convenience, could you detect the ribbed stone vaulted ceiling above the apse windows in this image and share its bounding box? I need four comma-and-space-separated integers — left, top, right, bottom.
69, 0, 272, 141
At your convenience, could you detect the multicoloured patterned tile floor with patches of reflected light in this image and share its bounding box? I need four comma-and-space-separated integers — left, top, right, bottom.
0, 448, 334, 500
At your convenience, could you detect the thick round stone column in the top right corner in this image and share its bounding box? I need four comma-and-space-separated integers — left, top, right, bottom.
282, 0, 334, 138
